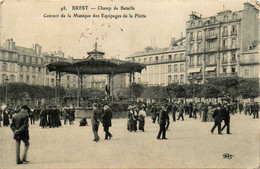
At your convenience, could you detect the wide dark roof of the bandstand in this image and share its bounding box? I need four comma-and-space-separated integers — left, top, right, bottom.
46, 58, 145, 75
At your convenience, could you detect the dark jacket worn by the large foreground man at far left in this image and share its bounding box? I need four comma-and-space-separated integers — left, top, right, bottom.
11, 112, 29, 140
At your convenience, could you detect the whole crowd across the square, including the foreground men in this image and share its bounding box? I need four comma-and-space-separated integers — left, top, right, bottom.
0, 100, 259, 164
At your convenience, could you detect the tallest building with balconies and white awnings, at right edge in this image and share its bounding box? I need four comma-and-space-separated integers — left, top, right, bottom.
186, 3, 259, 82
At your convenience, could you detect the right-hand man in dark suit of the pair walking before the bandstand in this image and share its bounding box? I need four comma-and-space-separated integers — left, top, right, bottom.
102, 105, 113, 140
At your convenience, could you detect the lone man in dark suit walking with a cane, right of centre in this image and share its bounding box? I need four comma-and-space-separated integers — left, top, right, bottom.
157, 105, 169, 139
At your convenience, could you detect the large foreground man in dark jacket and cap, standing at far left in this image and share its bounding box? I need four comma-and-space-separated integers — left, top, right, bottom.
11, 105, 30, 164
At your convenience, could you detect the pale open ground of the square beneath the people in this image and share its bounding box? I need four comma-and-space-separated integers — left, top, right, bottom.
0, 114, 260, 169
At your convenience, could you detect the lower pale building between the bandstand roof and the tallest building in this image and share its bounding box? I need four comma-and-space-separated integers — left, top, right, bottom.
126, 37, 186, 86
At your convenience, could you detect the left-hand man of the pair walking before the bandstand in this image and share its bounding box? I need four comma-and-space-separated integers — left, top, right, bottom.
91, 103, 101, 142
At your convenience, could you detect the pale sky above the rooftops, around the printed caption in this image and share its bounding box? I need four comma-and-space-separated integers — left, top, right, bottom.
0, 0, 254, 59
